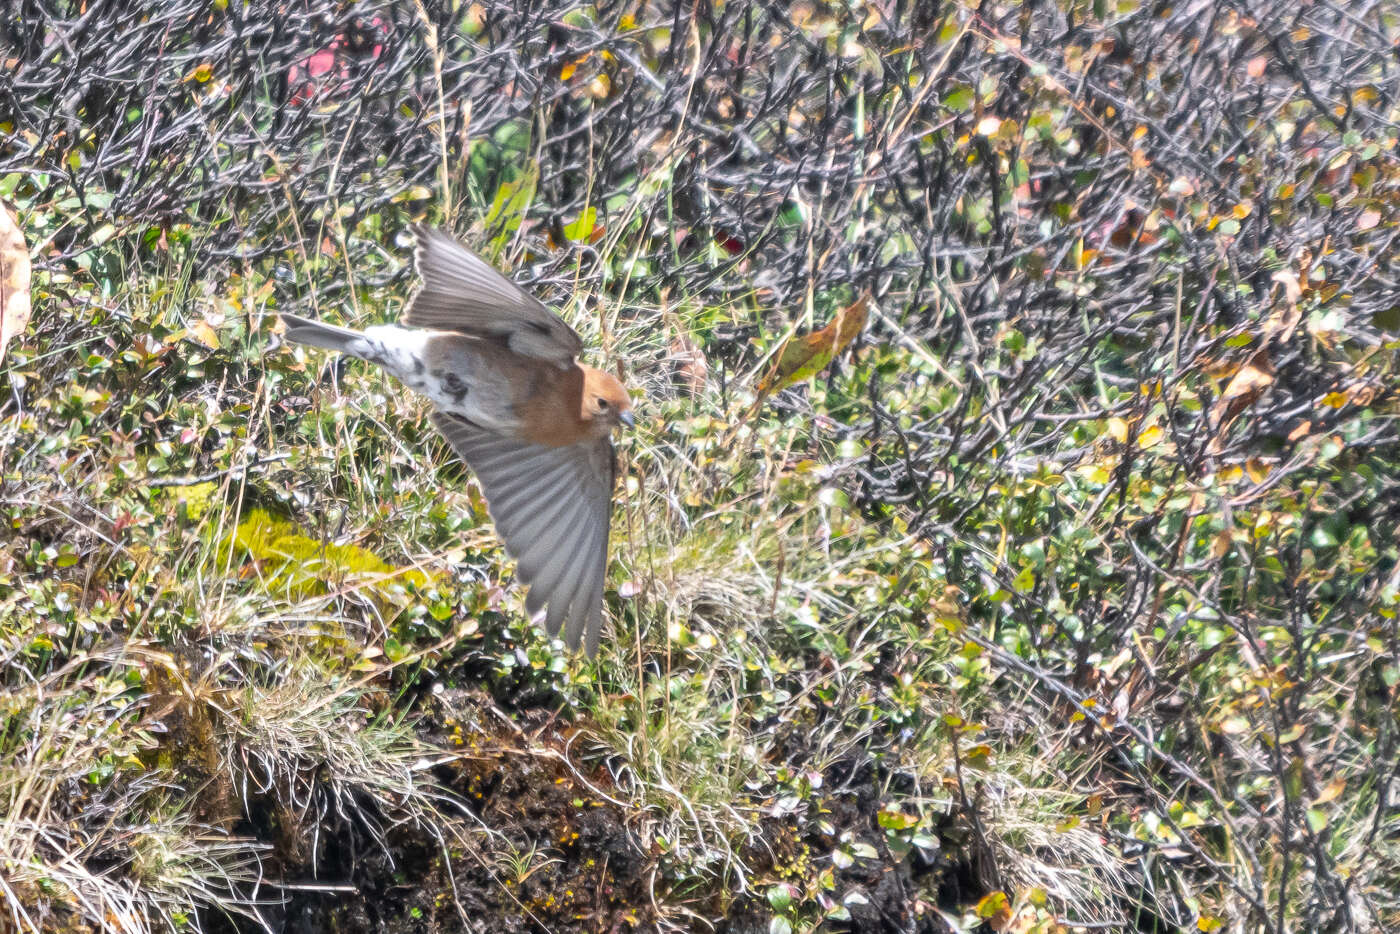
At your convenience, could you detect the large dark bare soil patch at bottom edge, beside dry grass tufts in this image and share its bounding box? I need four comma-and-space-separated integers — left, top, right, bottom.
211, 690, 657, 934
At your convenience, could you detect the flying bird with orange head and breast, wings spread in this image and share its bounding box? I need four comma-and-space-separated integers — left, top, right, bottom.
280, 224, 634, 657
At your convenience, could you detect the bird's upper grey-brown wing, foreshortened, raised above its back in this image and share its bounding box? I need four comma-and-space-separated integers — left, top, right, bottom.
403, 224, 584, 367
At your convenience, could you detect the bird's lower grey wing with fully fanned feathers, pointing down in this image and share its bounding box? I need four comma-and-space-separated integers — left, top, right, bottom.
431, 412, 615, 655
